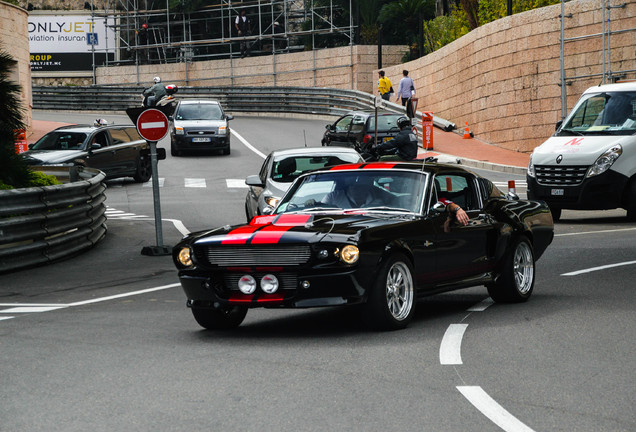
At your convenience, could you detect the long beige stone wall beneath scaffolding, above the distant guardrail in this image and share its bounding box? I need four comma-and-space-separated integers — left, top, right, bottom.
98, 45, 408, 93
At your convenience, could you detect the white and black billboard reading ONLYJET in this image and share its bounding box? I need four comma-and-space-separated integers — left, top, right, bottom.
29, 15, 115, 72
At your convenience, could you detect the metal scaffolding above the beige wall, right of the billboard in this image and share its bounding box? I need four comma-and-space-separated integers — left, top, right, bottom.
92, 0, 355, 66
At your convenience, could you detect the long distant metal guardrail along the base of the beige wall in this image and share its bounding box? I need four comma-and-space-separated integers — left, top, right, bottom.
32, 86, 456, 131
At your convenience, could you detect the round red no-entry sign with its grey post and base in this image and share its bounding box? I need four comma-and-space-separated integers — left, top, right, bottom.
134, 108, 170, 256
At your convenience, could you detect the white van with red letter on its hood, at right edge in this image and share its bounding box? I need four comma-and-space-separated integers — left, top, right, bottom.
527, 82, 636, 221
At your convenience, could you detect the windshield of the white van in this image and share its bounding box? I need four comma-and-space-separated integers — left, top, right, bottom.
558, 92, 636, 135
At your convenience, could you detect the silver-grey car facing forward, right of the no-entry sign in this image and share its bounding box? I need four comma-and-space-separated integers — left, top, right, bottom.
170, 99, 234, 156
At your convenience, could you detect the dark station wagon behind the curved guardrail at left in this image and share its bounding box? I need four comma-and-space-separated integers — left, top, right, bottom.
21, 125, 152, 183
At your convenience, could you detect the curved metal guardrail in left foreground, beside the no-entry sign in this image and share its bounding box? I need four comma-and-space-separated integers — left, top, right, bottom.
0, 167, 107, 272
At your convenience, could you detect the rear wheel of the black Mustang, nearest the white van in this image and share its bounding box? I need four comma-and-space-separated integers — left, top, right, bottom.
487, 236, 535, 303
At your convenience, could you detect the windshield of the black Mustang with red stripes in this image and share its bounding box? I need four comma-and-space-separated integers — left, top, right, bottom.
275, 170, 428, 214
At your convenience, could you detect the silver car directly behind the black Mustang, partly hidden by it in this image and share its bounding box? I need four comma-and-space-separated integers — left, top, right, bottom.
245, 147, 363, 222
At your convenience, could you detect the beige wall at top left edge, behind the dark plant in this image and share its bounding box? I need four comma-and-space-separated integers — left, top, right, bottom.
0, 1, 33, 131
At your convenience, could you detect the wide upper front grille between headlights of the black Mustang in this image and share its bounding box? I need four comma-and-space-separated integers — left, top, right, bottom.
205, 245, 311, 267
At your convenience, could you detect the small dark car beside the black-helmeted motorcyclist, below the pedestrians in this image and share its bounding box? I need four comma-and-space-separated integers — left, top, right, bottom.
321, 111, 408, 152
